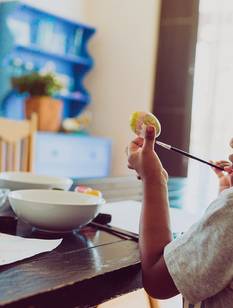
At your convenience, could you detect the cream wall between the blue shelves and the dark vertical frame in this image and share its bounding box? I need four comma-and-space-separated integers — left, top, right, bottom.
21, 0, 161, 175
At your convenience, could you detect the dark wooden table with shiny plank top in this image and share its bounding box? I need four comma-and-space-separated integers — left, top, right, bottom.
0, 217, 142, 308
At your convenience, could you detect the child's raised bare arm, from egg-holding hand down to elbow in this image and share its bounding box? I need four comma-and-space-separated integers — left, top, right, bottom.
129, 127, 179, 299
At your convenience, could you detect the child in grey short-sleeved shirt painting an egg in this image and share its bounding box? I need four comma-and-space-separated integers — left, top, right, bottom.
128, 126, 233, 308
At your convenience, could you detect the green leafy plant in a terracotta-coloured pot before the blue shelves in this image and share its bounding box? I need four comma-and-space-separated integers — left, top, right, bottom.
11, 72, 63, 131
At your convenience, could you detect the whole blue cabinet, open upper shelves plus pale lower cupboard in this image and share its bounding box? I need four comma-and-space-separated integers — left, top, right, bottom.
0, 1, 111, 178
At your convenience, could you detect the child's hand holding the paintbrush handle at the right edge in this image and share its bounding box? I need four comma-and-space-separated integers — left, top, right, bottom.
212, 139, 233, 192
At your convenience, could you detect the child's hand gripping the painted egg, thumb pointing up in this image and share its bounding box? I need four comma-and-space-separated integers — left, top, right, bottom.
128, 126, 168, 182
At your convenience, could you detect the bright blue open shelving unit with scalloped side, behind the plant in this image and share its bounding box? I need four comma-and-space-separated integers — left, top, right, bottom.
0, 1, 96, 119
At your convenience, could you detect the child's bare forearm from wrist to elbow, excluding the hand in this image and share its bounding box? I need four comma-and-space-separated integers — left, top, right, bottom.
139, 173, 179, 299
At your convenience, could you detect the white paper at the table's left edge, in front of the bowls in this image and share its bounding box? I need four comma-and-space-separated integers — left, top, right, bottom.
0, 233, 62, 265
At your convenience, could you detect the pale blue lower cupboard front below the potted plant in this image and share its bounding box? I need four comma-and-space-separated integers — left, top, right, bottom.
35, 133, 111, 178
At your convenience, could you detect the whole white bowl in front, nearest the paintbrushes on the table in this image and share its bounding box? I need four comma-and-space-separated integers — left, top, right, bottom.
8, 189, 105, 232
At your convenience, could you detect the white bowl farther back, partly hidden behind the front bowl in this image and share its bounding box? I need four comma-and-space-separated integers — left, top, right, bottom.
0, 172, 73, 190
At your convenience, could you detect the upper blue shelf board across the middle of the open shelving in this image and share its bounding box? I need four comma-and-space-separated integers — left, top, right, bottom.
15, 43, 93, 67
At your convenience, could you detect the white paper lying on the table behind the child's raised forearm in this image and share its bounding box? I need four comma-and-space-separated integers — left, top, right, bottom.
101, 200, 198, 233
